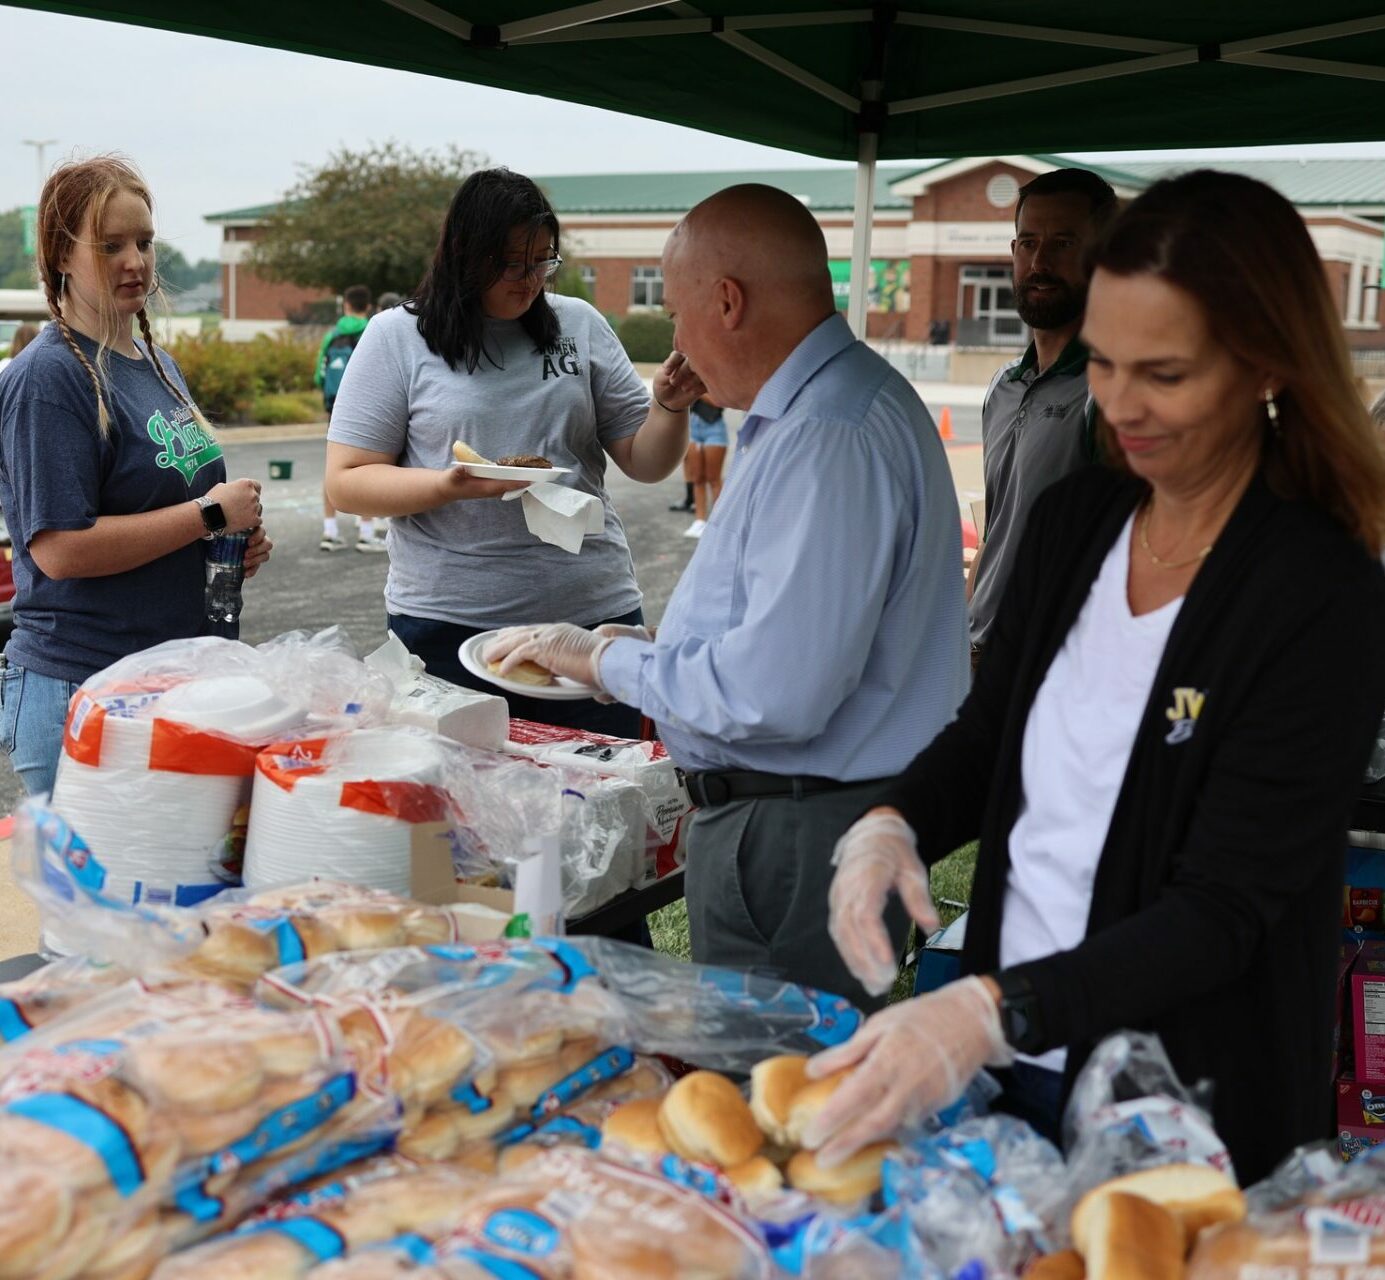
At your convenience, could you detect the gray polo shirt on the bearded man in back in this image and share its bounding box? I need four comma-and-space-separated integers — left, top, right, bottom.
971, 338, 1094, 644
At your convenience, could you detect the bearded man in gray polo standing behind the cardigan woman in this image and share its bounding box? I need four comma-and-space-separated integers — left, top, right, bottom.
968, 169, 1116, 666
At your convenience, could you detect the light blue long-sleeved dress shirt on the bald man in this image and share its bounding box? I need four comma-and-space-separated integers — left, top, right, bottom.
601, 316, 970, 781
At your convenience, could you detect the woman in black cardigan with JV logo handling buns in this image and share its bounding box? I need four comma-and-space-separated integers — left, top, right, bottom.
809, 172, 1385, 1183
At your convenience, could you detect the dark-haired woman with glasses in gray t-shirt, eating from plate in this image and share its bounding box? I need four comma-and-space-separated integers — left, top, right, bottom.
319, 169, 704, 737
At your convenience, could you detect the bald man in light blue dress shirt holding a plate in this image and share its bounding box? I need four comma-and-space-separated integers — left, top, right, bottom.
488, 186, 968, 1007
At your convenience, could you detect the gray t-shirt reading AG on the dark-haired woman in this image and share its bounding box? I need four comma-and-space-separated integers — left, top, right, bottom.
327, 295, 650, 629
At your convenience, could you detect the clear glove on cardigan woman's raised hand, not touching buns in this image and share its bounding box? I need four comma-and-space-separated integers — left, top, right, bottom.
827, 809, 939, 996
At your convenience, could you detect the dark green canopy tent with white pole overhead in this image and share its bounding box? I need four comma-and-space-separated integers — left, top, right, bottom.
21, 0, 1385, 331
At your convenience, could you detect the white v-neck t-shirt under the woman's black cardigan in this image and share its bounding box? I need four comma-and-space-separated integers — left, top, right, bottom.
1000, 517, 1183, 1071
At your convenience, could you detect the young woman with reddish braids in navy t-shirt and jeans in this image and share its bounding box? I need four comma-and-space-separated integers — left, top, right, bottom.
0, 155, 271, 795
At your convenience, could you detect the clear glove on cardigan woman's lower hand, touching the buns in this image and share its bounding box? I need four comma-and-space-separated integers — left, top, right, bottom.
803, 978, 1014, 1168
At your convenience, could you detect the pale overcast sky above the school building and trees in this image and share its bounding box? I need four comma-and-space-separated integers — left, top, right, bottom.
0, 0, 1385, 259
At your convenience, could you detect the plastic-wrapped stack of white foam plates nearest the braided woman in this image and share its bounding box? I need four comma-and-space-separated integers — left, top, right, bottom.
44, 633, 388, 953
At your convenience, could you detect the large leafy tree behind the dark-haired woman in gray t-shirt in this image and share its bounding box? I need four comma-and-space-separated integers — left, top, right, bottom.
253, 141, 488, 296
